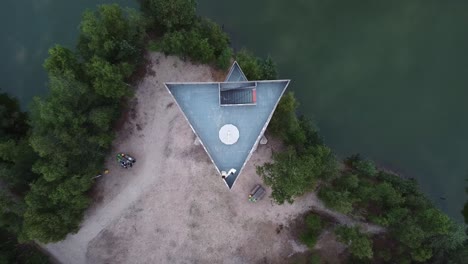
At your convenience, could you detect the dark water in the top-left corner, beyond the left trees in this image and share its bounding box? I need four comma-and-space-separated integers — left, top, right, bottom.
0, 0, 137, 108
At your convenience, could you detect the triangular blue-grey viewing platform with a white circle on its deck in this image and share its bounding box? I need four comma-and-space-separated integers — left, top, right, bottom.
165, 62, 290, 189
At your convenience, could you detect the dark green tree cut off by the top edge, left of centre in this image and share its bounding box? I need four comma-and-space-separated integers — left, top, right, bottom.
141, 0, 197, 31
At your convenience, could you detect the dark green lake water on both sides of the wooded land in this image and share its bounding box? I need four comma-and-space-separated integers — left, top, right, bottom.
0, 0, 468, 219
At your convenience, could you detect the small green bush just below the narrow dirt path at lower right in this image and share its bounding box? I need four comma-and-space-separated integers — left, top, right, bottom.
335, 226, 373, 259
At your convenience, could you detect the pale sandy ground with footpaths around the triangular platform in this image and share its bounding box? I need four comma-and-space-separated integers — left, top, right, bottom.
45, 53, 380, 264
